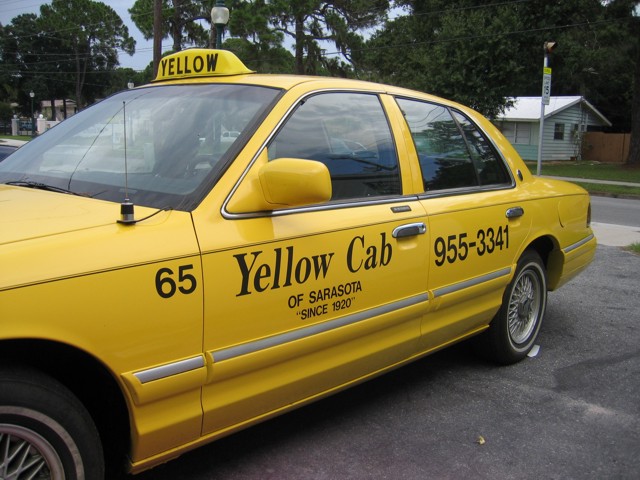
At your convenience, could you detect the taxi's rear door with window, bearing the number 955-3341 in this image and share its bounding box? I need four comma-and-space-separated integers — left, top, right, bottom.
397, 98, 530, 348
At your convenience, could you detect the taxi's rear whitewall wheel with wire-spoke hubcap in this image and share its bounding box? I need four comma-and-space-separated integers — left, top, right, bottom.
477, 250, 547, 365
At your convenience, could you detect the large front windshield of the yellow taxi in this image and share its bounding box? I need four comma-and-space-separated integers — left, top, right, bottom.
0, 84, 279, 211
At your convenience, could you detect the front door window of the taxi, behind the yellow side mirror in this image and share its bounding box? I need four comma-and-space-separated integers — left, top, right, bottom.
268, 92, 402, 200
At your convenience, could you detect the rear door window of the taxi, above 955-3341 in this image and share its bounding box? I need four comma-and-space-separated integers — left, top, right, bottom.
397, 98, 510, 192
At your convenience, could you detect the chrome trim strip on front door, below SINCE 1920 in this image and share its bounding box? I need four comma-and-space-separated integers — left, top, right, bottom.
209, 292, 429, 364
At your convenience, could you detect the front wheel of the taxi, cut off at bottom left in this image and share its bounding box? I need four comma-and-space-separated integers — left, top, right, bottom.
0, 367, 104, 480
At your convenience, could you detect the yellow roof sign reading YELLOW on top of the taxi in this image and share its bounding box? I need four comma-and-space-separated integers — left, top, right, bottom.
154, 48, 255, 82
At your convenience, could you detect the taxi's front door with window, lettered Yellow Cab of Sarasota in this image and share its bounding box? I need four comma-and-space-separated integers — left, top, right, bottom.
194, 92, 428, 434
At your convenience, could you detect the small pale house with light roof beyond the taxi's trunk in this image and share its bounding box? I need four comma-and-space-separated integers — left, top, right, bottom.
494, 96, 611, 160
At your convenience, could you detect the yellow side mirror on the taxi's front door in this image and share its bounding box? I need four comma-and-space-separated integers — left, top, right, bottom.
227, 158, 332, 213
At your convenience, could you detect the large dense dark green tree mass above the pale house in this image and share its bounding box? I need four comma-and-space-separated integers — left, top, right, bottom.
356, 0, 638, 127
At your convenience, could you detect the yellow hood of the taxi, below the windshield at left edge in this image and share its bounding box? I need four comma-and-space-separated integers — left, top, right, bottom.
0, 185, 120, 245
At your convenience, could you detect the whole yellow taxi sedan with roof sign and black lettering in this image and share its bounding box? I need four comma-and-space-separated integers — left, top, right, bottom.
0, 49, 596, 479
